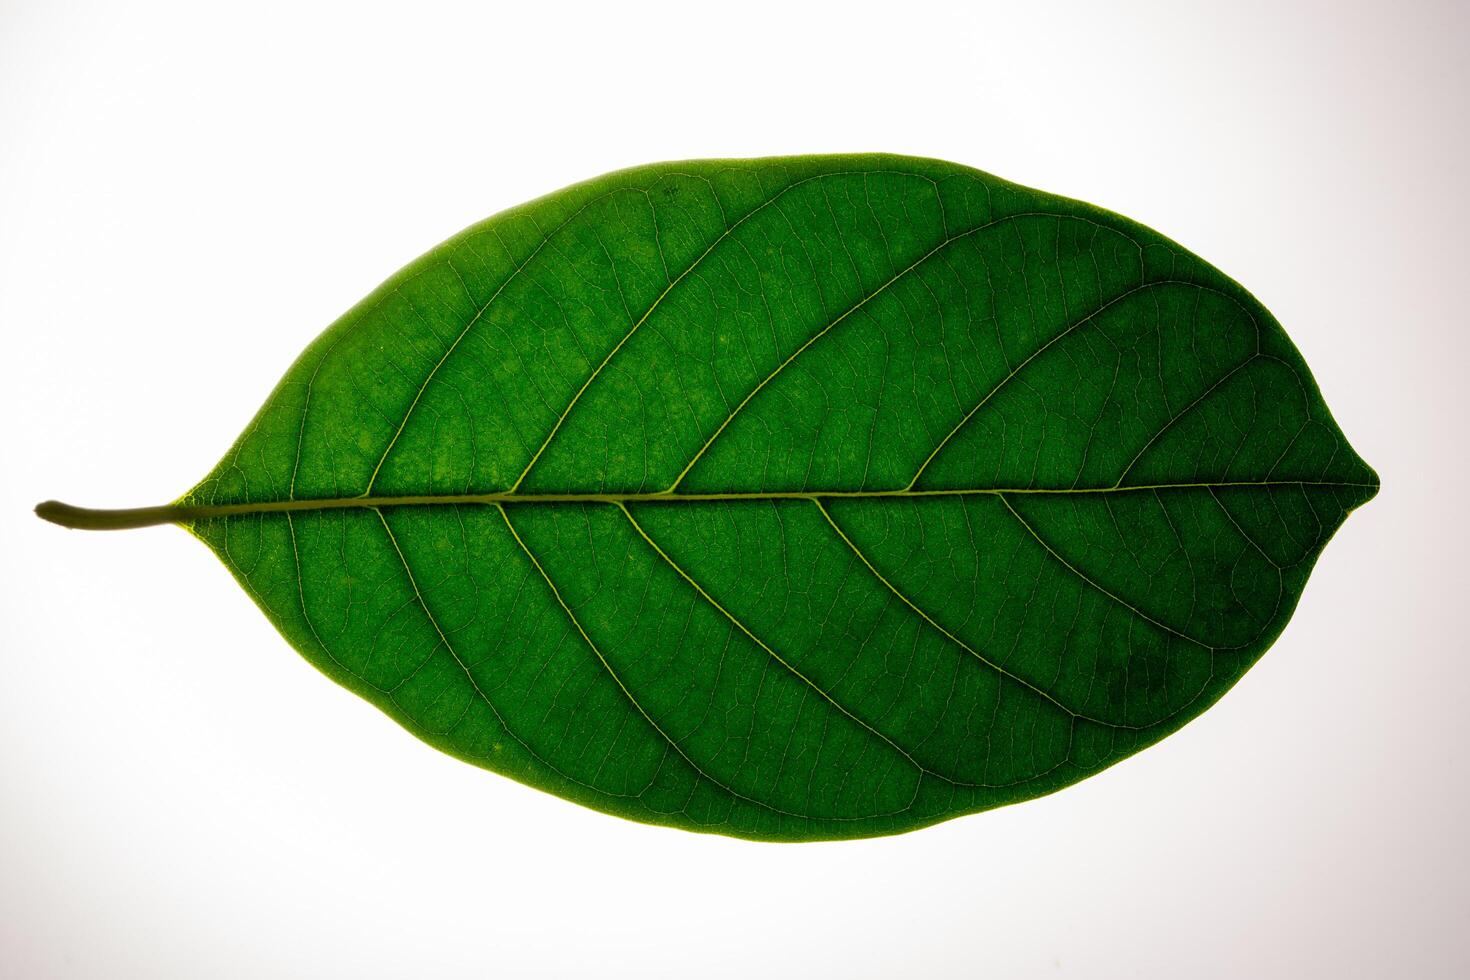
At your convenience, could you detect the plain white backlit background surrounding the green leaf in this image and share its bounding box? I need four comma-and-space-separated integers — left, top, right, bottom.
0, 0, 1470, 977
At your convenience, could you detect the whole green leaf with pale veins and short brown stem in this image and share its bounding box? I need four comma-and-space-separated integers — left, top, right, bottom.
40, 156, 1377, 840
